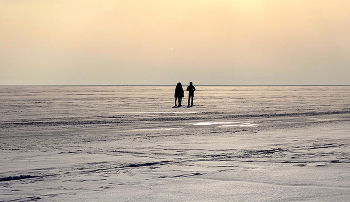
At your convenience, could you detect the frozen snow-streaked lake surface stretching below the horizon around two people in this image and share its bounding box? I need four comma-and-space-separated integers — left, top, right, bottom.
0, 86, 350, 201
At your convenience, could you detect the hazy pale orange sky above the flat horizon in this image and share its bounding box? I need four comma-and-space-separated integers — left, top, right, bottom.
0, 0, 350, 85
